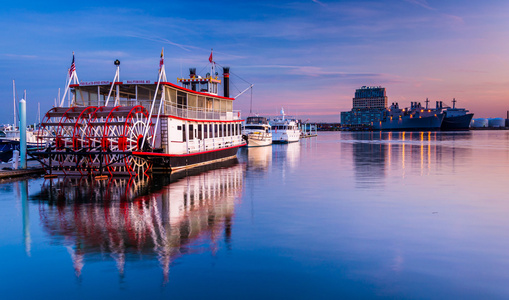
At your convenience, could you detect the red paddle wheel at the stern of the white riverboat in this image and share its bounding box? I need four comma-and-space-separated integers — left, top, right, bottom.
36, 105, 154, 176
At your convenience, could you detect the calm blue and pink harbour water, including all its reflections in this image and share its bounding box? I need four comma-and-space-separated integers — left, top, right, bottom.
0, 131, 509, 299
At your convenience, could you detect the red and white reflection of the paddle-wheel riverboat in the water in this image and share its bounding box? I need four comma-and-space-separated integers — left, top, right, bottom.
35, 159, 243, 282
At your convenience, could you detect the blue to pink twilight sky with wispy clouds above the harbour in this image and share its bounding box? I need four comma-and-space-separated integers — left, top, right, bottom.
0, 0, 509, 123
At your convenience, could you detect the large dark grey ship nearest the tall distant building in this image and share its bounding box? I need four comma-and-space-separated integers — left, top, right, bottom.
372, 102, 444, 131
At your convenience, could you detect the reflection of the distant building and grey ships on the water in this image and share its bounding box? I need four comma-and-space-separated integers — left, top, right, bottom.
342, 131, 472, 188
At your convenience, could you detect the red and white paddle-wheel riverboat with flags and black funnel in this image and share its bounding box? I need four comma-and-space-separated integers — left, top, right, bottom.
32, 49, 246, 176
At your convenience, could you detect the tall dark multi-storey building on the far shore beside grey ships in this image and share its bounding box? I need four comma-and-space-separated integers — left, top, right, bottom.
341, 86, 387, 127
